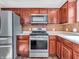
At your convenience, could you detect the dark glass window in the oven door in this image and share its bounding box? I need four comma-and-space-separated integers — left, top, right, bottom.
31, 40, 47, 50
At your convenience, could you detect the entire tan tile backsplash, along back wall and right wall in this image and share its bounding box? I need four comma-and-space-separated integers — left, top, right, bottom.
22, 22, 79, 32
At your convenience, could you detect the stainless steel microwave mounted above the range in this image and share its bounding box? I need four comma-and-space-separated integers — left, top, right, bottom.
31, 14, 48, 24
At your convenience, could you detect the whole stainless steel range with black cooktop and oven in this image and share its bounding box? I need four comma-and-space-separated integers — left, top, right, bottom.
29, 30, 48, 57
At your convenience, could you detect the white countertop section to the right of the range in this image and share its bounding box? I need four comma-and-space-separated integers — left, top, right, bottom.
48, 31, 79, 44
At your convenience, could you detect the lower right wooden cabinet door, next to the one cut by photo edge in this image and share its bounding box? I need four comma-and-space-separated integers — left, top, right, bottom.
62, 45, 72, 59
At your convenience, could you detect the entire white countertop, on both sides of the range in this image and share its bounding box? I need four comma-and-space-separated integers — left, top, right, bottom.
17, 31, 79, 44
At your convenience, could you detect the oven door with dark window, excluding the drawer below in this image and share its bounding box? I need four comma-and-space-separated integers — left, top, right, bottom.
29, 40, 48, 53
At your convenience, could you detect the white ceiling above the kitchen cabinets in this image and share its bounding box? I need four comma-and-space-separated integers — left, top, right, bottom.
0, 0, 67, 8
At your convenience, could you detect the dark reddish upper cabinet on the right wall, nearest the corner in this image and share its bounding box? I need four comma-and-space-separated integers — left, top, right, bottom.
60, 3, 68, 23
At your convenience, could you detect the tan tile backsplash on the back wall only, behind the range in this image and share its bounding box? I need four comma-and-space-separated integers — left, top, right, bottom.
22, 24, 64, 31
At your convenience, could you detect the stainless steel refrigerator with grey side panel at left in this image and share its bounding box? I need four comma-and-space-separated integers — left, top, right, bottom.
0, 11, 21, 59
